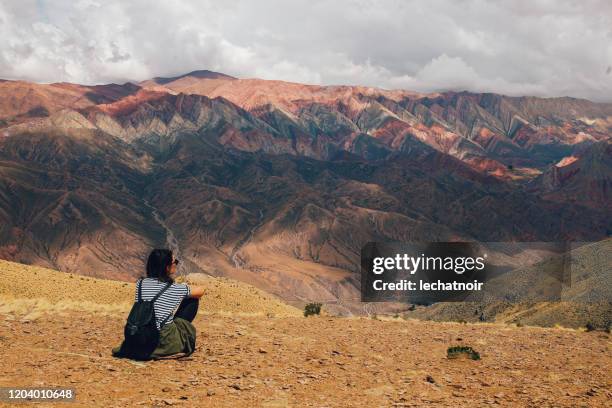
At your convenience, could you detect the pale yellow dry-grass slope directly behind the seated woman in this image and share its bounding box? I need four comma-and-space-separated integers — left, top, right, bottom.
0, 260, 301, 320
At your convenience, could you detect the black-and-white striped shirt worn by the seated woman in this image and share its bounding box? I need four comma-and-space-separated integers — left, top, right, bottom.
134, 278, 191, 329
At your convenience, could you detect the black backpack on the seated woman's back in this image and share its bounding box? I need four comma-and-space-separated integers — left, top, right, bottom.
123, 279, 172, 360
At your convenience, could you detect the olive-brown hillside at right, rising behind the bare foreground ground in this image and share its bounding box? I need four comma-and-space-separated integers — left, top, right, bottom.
406, 238, 612, 328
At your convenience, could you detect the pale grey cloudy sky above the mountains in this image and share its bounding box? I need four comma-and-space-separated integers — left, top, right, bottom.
0, 0, 612, 101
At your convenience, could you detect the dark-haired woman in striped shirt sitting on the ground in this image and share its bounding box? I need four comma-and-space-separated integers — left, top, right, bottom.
113, 249, 204, 359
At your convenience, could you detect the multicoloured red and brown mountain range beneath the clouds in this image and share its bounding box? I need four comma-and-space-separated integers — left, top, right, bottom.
0, 71, 612, 309
